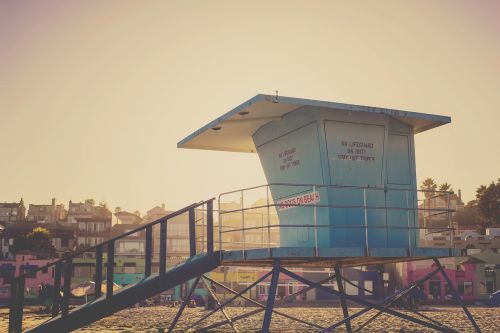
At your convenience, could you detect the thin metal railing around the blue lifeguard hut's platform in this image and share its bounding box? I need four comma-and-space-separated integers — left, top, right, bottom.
218, 183, 455, 255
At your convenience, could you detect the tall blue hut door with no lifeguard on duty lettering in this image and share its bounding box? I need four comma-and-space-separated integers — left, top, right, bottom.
325, 120, 387, 248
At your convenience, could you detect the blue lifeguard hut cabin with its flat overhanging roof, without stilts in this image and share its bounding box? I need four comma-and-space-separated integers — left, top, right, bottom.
178, 95, 450, 258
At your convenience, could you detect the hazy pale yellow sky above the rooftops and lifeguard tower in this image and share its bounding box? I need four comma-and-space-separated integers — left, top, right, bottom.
0, 0, 500, 213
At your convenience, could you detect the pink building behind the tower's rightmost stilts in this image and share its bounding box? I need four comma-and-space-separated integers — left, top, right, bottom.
398, 258, 476, 301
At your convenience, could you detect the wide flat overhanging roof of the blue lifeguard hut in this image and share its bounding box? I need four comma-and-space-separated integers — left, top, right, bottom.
177, 94, 451, 153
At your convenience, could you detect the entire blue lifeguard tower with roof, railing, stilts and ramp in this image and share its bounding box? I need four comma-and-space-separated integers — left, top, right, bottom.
9, 95, 480, 333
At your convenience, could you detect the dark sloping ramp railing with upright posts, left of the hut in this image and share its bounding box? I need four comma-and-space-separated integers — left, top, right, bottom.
9, 198, 215, 333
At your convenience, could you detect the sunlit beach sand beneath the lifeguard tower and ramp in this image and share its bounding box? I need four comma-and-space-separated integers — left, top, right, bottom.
0, 306, 500, 333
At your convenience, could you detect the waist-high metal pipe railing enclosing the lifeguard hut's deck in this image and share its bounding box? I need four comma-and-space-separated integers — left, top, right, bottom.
218, 183, 454, 254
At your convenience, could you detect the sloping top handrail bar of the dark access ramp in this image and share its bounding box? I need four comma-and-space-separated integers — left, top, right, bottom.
9, 198, 215, 280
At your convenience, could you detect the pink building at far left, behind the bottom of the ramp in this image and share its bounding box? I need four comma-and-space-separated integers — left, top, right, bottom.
0, 252, 62, 303
